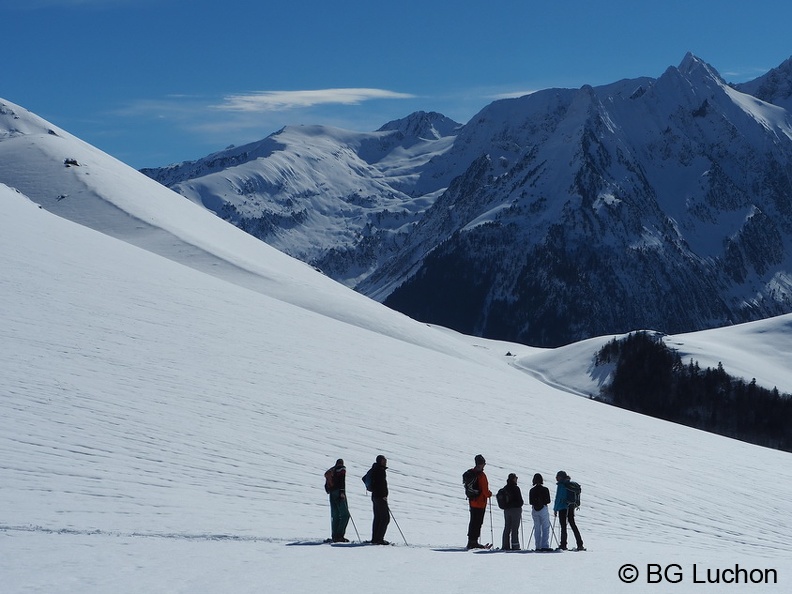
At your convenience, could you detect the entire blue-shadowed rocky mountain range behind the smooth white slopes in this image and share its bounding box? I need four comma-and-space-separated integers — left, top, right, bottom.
142, 54, 792, 346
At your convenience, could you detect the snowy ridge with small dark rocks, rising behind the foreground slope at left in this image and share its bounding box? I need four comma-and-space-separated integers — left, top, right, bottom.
0, 100, 482, 360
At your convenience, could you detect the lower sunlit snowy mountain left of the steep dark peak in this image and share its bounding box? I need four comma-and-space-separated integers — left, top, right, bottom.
143, 112, 460, 286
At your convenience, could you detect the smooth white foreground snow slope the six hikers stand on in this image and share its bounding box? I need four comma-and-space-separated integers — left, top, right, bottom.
0, 182, 792, 592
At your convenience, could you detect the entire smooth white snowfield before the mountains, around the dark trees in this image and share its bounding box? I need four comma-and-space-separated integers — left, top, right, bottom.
0, 80, 792, 594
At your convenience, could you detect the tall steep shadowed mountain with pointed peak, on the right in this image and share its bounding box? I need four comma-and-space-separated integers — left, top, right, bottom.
374, 55, 792, 345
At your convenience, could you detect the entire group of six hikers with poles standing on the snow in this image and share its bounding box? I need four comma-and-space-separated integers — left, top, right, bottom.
325, 454, 585, 552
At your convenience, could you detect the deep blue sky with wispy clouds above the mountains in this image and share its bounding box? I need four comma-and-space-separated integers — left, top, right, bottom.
0, 0, 792, 168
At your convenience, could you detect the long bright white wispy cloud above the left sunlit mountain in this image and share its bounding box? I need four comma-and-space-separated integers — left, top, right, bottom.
214, 89, 415, 112
